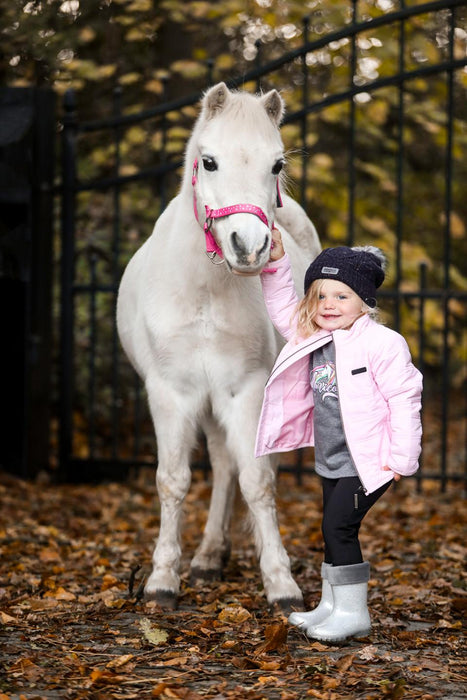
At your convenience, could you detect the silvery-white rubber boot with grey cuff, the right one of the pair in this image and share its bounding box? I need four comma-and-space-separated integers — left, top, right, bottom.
306, 561, 371, 642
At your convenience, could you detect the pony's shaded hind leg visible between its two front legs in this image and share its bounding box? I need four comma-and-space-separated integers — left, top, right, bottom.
191, 420, 237, 580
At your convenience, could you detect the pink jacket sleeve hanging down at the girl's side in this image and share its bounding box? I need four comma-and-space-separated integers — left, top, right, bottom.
373, 331, 423, 476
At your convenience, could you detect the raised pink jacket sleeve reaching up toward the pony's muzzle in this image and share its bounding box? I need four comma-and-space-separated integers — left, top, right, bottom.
260, 253, 299, 340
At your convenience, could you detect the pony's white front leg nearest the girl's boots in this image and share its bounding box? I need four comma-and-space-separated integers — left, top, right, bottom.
219, 373, 303, 612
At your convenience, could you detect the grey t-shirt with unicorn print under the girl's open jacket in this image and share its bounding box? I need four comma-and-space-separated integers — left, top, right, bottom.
310, 341, 357, 479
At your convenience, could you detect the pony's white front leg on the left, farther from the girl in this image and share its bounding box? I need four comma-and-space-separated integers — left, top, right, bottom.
144, 372, 196, 609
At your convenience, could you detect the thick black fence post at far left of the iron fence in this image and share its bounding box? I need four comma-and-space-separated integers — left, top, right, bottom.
59, 90, 78, 479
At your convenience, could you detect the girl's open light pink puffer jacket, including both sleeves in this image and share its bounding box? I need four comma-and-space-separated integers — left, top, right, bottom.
256, 255, 422, 493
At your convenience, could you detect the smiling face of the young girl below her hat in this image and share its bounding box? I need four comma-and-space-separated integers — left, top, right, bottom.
314, 279, 363, 331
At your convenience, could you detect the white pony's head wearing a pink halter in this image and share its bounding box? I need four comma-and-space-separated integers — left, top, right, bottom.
186, 83, 284, 275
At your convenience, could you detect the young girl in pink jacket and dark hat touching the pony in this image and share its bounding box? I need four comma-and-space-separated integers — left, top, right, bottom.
256, 229, 422, 642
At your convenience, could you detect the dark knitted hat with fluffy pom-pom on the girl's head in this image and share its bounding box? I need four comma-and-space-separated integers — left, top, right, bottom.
305, 246, 386, 308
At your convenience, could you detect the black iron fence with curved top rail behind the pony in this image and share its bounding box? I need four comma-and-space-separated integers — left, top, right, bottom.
59, 0, 467, 489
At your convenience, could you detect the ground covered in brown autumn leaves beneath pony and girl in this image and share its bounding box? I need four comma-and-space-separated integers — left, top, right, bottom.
0, 473, 467, 700
